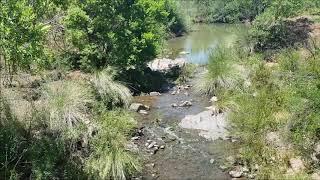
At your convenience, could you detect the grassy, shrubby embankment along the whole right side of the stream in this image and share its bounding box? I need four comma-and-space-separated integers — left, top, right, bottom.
199, 3, 320, 179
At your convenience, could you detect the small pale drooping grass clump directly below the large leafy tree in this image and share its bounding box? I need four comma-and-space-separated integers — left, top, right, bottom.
92, 71, 132, 108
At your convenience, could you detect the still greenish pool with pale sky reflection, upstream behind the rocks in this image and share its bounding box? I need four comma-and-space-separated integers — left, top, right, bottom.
168, 24, 247, 64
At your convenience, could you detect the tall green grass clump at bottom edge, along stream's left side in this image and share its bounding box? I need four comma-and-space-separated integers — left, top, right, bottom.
86, 110, 140, 180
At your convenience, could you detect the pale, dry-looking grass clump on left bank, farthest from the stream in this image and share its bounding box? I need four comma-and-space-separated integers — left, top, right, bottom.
43, 81, 94, 135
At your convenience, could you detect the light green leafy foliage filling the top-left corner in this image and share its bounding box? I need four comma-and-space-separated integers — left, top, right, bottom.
0, 0, 49, 73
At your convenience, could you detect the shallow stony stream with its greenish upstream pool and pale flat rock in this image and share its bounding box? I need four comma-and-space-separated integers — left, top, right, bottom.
134, 24, 245, 180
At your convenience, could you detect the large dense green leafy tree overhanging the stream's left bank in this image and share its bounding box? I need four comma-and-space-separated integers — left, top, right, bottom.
64, 0, 183, 70
